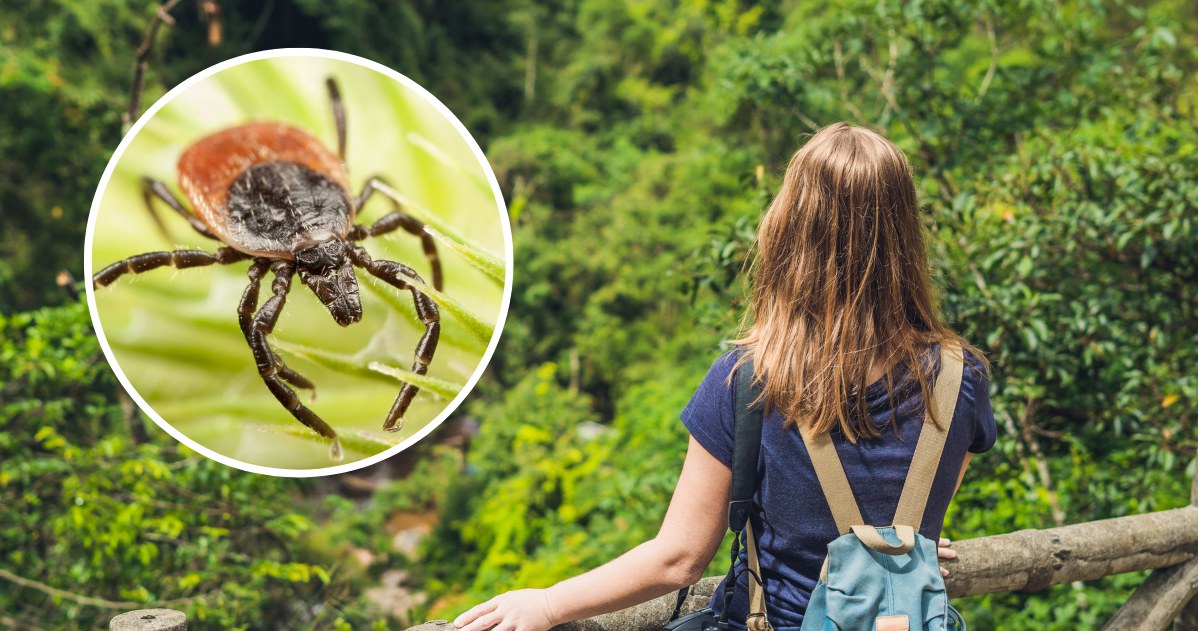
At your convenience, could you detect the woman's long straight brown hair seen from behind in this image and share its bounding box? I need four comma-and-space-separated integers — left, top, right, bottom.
734, 123, 988, 442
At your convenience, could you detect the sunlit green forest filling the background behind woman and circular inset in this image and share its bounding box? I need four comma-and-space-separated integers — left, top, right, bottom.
0, 0, 1198, 630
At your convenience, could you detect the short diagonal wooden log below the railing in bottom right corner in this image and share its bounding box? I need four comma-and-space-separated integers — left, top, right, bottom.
1102, 558, 1198, 631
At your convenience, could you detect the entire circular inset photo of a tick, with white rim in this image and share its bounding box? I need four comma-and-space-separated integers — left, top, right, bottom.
85, 49, 512, 477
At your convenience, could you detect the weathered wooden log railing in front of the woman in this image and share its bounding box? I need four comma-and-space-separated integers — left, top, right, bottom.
110, 457, 1198, 631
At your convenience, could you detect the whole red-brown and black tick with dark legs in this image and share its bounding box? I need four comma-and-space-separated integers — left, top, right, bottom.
92, 79, 442, 460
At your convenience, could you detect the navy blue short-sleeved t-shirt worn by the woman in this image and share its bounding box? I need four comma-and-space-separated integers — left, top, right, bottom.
682, 345, 997, 631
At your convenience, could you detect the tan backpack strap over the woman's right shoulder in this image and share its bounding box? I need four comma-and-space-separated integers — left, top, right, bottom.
894, 341, 964, 530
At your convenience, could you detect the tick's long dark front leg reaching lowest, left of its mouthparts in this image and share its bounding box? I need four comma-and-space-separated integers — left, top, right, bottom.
245, 261, 341, 460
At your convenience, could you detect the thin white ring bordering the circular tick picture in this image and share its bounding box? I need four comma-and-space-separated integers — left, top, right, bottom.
83, 48, 513, 478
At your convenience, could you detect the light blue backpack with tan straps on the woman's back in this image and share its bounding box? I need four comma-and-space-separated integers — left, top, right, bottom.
720, 342, 966, 631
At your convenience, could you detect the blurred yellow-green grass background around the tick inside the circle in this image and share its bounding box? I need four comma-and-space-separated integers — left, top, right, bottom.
91, 56, 504, 469
